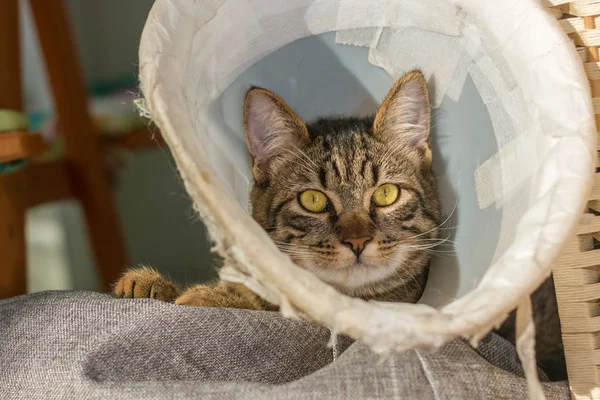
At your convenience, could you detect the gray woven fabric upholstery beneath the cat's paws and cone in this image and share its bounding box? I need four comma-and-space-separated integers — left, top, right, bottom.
0, 292, 569, 399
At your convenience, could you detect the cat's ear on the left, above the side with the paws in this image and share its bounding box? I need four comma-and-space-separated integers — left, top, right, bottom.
244, 87, 308, 183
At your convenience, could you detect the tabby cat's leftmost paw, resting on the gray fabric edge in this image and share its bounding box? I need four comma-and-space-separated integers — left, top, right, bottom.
114, 267, 181, 302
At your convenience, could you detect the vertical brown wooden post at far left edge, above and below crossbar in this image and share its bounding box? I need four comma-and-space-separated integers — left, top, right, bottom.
0, 0, 27, 299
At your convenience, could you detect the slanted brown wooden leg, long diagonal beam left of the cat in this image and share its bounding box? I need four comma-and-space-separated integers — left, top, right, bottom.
29, 0, 127, 290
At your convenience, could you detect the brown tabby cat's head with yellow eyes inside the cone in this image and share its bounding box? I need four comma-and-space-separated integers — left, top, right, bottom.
244, 72, 440, 302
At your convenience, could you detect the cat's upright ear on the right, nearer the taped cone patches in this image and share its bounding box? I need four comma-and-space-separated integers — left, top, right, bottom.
373, 71, 431, 156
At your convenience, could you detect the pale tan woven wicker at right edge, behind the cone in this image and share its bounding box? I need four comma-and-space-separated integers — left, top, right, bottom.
545, 0, 600, 399
